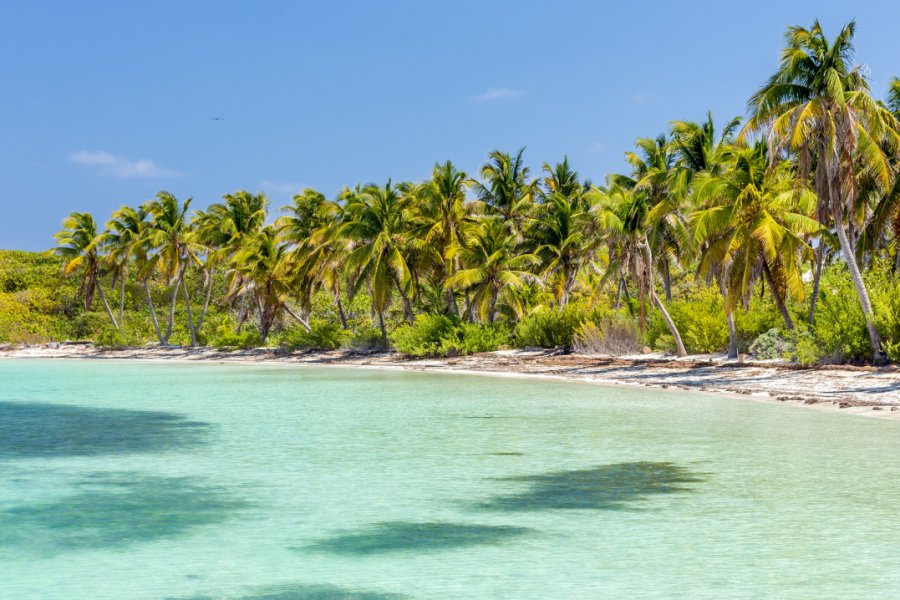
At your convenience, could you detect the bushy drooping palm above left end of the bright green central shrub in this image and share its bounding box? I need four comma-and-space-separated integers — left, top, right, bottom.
335, 181, 415, 339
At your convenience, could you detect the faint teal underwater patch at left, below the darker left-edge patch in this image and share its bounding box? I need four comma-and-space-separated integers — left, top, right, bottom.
0, 473, 247, 554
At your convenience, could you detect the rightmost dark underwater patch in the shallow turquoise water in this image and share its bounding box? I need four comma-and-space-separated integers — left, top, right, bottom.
478, 462, 704, 512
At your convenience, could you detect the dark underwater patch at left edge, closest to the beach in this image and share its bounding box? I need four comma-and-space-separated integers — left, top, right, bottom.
0, 401, 210, 459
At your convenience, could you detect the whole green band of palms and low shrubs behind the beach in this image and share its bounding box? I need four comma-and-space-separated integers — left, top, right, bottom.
0, 23, 900, 363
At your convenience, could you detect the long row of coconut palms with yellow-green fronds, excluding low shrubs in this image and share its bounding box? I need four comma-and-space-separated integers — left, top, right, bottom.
57, 23, 900, 360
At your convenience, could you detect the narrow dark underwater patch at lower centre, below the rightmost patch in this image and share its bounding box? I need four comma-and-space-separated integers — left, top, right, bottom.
298, 521, 532, 556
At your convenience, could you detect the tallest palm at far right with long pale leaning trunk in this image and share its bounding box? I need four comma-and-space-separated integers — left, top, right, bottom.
741, 21, 900, 362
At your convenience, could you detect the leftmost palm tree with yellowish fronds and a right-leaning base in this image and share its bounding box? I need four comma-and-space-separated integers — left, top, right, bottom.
54, 212, 119, 329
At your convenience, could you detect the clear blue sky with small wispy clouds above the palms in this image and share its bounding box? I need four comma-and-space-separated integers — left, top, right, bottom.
0, 0, 900, 250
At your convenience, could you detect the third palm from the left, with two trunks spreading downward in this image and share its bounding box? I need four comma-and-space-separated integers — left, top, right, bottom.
142, 192, 200, 346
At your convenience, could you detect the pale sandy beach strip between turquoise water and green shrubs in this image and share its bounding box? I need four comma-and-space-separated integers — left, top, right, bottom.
0, 344, 900, 420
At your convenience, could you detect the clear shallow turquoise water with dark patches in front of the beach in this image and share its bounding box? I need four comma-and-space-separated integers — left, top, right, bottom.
0, 360, 900, 600
